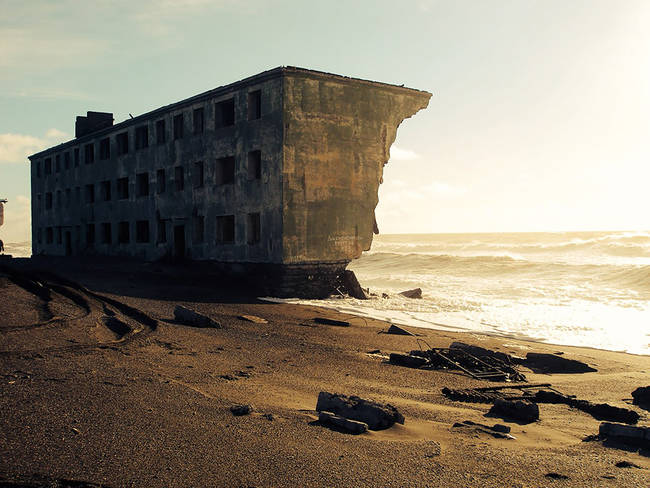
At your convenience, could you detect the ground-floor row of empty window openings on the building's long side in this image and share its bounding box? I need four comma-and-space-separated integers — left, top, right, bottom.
37, 212, 261, 245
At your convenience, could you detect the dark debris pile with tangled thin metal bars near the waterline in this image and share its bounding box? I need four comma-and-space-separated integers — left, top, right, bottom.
390, 341, 526, 381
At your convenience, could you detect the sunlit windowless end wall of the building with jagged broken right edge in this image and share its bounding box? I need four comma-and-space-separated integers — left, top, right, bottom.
282, 70, 431, 263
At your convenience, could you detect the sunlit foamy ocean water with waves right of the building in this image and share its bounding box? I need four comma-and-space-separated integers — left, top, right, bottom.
280, 232, 650, 355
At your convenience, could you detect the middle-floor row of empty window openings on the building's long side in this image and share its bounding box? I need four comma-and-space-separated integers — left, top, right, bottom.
38, 150, 262, 210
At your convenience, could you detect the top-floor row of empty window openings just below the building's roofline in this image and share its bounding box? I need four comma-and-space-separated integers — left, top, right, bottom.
36, 90, 262, 178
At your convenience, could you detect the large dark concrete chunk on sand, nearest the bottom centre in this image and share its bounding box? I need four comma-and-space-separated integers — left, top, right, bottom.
316, 391, 404, 430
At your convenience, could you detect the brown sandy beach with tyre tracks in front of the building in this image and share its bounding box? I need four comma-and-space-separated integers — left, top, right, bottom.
0, 259, 650, 487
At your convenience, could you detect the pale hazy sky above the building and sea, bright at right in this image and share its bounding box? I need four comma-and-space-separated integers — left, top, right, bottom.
0, 0, 650, 241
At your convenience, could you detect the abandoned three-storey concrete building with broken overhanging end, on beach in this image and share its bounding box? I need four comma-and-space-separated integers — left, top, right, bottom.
29, 67, 431, 296
